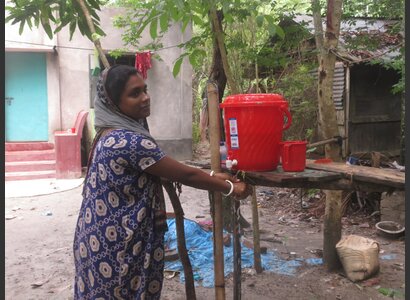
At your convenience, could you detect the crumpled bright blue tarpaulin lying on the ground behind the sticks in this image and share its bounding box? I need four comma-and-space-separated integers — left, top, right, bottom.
165, 219, 322, 287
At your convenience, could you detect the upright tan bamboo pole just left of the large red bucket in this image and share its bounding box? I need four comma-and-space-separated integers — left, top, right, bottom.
207, 83, 225, 300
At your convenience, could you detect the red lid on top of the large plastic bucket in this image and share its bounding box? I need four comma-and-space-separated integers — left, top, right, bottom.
219, 94, 288, 108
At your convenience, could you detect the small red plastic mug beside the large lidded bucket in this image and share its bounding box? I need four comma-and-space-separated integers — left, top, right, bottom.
281, 141, 307, 172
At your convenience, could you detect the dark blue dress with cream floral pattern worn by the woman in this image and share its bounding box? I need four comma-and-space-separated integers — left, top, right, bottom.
73, 129, 166, 299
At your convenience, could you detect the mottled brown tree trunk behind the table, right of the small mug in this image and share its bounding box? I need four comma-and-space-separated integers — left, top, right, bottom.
312, 0, 343, 271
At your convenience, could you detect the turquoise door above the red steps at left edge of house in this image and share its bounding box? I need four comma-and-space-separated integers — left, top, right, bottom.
5, 52, 48, 142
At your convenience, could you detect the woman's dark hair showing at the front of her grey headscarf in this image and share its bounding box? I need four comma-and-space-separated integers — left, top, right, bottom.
104, 65, 139, 106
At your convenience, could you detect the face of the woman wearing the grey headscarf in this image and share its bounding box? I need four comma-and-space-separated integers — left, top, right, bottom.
118, 74, 151, 120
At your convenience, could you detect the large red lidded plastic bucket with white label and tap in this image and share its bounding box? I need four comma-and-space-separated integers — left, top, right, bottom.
220, 94, 292, 171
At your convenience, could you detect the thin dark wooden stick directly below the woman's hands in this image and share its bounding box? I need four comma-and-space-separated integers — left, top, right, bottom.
232, 199, 242, 300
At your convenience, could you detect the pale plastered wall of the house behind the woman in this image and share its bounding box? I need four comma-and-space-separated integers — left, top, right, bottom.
5, 8, 192, 159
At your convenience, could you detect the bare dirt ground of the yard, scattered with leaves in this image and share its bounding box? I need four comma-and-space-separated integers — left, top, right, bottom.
5, 149, 405, 300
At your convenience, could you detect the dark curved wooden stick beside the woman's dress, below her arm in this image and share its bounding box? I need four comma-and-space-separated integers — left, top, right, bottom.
161, 179, 196, 300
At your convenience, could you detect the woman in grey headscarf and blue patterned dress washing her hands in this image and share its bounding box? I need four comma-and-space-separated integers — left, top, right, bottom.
74, 65, 249, 299
